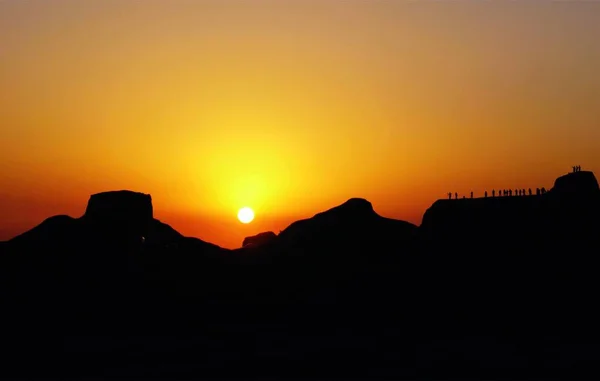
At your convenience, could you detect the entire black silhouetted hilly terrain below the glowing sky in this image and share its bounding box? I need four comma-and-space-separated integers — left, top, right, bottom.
0, 172, 600, 379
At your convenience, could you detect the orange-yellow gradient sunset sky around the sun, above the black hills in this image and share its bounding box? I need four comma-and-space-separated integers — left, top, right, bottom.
0, 0, 600, 247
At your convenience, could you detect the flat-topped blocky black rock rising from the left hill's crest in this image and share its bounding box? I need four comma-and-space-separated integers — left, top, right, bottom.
82, 190, 153, 236
